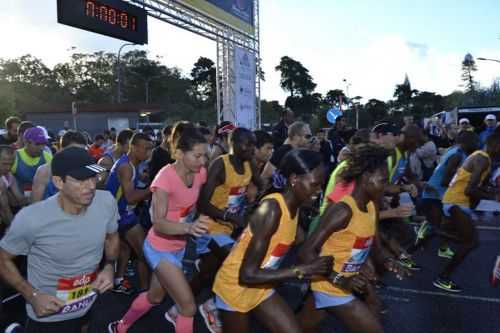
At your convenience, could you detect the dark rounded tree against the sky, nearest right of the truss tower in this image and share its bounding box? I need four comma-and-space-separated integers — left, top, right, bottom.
275, 56, 316, 97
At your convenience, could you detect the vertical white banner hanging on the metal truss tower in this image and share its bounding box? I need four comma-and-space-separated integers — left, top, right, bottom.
233, 47, 257, 129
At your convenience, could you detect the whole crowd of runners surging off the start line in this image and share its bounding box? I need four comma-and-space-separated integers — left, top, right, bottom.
0, 110, 500, 333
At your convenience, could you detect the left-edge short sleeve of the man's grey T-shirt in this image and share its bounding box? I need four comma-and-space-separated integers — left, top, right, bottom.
0, 208, 35, 255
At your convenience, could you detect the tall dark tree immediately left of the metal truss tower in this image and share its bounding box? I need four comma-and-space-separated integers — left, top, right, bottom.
191, 57, 217, 104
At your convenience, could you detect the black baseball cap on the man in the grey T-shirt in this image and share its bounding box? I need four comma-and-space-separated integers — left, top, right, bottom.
51, 147, 106, 180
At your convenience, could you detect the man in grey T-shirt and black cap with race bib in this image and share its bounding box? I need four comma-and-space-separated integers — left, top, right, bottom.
0, 147, 119, 333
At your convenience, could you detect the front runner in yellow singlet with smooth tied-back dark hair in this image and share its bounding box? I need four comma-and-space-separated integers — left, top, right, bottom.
213, 149, 332, 333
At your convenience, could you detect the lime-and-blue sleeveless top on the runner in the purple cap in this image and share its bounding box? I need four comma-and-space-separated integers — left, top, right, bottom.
11, 148, 52, 194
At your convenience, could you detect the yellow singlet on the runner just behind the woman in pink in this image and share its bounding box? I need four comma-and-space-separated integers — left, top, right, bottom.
208, 154, 252, 235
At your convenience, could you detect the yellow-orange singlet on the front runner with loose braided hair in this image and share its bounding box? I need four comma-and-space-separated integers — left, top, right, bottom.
311, 196, 377, 296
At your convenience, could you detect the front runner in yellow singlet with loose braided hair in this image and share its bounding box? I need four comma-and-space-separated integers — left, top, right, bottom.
299, 144, 407, 333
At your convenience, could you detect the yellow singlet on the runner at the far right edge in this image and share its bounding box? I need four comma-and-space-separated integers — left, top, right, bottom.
443, 150, 491, 208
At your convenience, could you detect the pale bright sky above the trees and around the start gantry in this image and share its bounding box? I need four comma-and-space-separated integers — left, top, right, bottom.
0, 0, 500, 102
